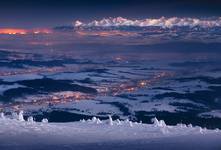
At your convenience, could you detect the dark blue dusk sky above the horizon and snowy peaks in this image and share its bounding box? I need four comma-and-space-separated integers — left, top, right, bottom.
0, 0, 221, 28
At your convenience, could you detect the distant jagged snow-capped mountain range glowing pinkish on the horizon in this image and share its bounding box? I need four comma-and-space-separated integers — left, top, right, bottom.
54, 17, 221, 32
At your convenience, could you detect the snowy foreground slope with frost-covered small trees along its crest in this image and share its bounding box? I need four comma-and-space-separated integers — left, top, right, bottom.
0, 113, 221, 150
